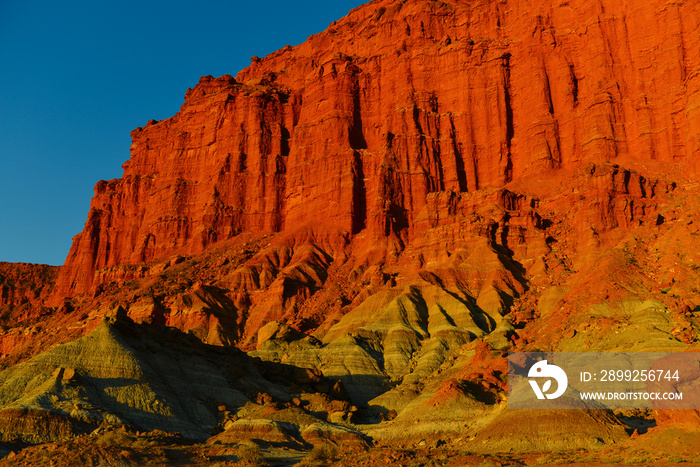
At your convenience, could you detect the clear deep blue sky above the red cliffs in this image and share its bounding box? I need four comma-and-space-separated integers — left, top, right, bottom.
0, 0, 364, 265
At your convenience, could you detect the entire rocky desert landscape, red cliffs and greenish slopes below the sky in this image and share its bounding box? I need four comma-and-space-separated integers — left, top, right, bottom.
0, 0, 700, 466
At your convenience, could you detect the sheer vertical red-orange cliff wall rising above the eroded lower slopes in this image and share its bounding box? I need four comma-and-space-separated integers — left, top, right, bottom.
54, 0, 700, 302
